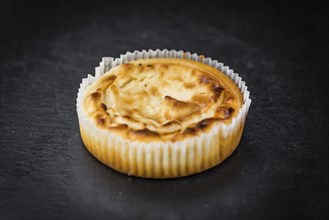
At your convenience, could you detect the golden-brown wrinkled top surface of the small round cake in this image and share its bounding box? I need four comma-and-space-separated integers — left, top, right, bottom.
83, 58, 242, 142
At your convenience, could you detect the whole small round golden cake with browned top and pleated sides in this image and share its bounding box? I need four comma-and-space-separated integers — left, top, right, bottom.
77, 50, 250, 178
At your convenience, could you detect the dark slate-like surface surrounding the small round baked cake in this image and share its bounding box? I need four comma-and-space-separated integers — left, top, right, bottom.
0, 0, 329, 219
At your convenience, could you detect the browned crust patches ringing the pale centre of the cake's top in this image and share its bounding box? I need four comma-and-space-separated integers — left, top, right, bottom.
83, 58, 243, 142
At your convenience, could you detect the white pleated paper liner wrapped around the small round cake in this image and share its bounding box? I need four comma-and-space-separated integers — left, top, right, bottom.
77, 49, 251, 178
